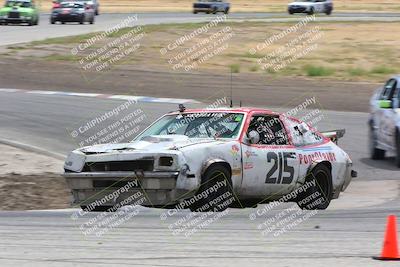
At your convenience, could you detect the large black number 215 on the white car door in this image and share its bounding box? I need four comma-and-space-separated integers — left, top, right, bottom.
265, 152, 296, 184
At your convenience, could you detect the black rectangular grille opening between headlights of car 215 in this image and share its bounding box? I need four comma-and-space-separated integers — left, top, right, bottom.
82, 159, 154, 172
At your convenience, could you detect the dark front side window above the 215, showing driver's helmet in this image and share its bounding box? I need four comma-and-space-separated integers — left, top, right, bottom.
247, 115, 289, 145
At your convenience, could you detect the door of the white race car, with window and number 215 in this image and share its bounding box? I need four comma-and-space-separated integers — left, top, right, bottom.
241, 114, 299, 198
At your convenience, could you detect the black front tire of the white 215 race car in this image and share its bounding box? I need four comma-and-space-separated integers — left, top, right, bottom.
190, 164, 235, 212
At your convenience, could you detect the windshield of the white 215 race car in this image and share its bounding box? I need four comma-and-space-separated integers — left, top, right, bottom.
135, 112, 244, 140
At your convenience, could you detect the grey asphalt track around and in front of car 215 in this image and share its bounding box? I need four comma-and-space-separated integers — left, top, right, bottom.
0, 89, 400, 267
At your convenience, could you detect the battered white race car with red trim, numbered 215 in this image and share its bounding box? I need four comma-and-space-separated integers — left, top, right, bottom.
64, 106, 357, 214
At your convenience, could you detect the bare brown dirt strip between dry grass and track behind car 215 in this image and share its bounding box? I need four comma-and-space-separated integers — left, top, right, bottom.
0, 59, 379, 112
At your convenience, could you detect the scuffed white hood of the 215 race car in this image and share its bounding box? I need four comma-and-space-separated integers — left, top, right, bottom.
79, 135, 222, 155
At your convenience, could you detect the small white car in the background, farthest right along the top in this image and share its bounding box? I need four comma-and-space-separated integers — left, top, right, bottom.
288, 0, 333, 15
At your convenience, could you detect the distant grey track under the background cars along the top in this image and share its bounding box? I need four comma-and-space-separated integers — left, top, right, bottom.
0, 13, 400, 46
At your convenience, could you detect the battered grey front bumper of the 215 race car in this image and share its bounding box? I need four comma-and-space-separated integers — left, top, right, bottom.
63, 171, 195, 207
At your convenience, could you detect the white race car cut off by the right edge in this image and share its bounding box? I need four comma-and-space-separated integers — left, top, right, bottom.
369, 76, 400, 168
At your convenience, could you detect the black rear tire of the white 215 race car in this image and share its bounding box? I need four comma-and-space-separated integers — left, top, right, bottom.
297, 163, 333, 210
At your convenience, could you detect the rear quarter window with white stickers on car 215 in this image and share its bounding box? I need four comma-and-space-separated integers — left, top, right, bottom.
286, 118, 324, 146
